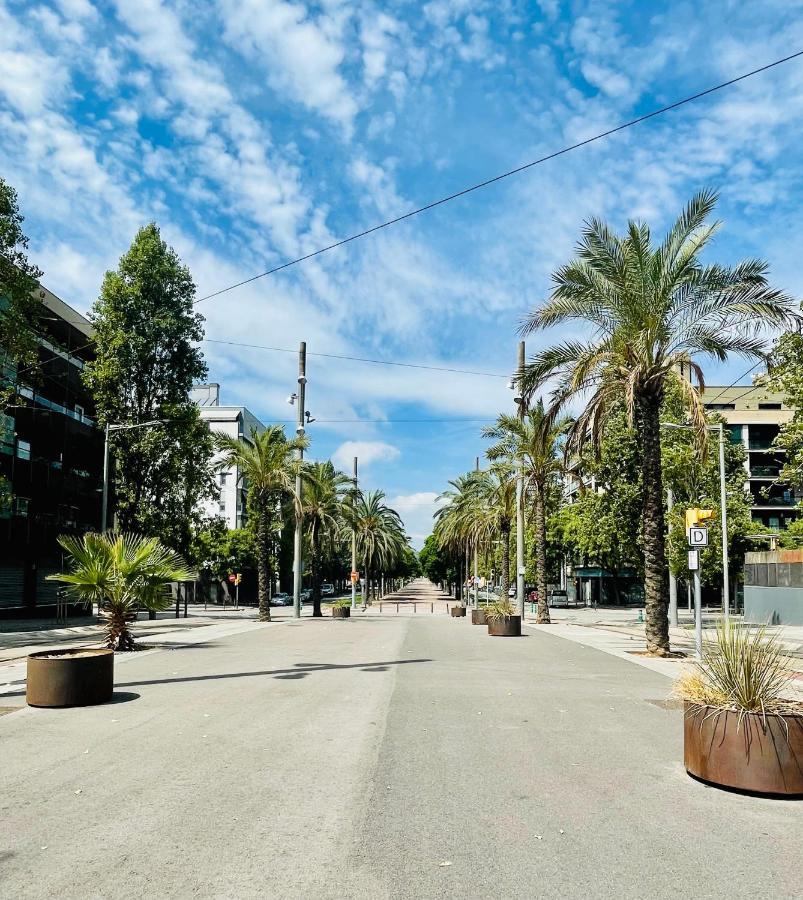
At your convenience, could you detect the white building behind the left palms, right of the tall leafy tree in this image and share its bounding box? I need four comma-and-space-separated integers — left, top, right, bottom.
190, 384, 265, 528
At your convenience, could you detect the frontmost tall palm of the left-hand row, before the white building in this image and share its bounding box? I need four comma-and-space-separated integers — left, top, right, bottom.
217, 425, 309, 622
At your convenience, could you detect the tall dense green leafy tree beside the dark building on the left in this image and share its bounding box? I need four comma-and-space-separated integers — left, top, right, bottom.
84, 224, 215, 555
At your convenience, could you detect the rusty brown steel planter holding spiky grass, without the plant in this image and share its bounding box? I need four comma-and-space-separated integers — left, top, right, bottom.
683, 701, 803, 798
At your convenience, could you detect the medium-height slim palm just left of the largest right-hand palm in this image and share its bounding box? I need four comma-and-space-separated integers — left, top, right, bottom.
482, 399, 571, 623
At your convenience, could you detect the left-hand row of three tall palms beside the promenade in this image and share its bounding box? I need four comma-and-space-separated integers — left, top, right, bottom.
218, 425, 409, 621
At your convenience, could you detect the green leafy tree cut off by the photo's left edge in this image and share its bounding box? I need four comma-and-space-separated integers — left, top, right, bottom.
0, 178, 43, 388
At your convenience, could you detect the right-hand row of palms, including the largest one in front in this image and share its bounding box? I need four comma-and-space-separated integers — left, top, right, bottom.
436, 190, 801, 655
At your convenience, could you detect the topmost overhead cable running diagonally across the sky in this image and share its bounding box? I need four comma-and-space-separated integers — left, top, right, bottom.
195, 50, 803, 303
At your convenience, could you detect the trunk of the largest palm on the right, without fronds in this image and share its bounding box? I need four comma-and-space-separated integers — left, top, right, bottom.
638, 396, 669, 656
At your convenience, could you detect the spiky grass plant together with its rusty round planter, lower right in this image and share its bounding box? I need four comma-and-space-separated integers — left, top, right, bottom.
674, 622, 803, 795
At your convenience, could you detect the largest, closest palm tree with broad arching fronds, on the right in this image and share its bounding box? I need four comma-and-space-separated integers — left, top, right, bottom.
522, 191, 798, 656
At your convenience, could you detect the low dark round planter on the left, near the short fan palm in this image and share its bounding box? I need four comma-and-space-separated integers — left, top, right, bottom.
26, 647, 114, 707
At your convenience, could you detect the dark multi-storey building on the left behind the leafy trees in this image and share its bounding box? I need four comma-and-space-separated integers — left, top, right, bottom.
0, 288, 103, 617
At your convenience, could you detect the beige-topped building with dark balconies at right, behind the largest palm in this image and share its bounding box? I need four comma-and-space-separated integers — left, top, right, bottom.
702, 385, 803, 530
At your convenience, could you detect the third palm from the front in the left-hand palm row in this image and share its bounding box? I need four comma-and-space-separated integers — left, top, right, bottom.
343, 491, 407, 605
